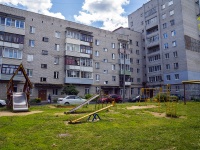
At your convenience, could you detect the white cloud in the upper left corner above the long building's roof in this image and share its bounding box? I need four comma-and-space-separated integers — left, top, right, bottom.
0, 0, 65, 19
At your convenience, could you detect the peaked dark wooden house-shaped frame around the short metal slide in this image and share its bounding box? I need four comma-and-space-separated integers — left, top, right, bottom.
7, 64, 32, 109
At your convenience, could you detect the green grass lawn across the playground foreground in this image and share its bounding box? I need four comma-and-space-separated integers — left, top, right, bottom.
0, 102, 200, 150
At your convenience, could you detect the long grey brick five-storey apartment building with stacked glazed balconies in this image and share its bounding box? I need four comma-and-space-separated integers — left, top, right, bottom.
0, 5, 143, 100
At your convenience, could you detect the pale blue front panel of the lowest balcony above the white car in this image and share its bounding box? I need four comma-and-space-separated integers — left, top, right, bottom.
65, 77, 93, 85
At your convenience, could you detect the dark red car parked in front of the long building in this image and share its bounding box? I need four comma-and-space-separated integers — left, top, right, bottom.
98, 94, 122, 103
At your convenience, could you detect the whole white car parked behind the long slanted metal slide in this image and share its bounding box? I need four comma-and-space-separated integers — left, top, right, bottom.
57, 95, 86, 105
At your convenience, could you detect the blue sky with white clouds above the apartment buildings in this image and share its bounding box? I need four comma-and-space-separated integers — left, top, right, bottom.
0, 0, 148, 31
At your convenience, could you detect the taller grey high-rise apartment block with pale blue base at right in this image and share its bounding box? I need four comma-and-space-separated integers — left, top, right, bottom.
128, 0, 200, 93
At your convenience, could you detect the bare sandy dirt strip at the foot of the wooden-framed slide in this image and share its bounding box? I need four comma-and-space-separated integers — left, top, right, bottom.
0, 111, 43, 117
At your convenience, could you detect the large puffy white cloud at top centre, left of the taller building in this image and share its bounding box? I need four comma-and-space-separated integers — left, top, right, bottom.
74, 0, 130, 30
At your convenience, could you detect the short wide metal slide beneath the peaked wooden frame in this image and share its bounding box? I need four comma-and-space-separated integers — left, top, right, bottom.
13, 92, 28, 111
